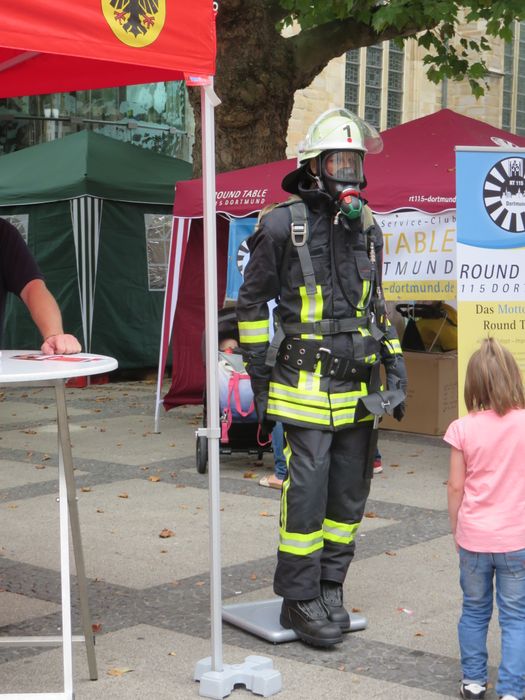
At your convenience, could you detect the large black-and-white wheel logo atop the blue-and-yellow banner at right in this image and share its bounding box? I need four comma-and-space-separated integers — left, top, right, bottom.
483, 156, 525, 233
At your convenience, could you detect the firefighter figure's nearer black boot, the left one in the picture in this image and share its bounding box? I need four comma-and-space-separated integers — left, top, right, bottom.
280, 598, 343, 647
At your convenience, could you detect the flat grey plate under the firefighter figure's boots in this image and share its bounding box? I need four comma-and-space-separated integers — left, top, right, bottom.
222, 598, 367, 644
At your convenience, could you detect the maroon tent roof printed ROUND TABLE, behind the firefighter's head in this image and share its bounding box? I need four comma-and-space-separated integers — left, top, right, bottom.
174, 109, 525, 218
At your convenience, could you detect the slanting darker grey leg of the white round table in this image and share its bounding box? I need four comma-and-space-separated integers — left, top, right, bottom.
55, 380, 98, 681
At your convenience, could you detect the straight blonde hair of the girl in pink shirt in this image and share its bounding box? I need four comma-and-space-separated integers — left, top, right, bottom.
464, 338, 525, 416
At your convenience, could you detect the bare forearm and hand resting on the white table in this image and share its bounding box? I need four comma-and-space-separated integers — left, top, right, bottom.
20, 279, 82, 355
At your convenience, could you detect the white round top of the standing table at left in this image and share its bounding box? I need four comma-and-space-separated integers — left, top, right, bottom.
0, 350, 118, 385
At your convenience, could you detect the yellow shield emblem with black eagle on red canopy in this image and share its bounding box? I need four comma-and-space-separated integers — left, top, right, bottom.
101, 0, 166, 48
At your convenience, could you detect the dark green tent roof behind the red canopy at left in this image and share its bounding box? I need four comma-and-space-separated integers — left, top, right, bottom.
0, 131, 192, 206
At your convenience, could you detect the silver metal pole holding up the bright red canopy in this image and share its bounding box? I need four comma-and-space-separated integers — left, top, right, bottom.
201, 82, 223, 671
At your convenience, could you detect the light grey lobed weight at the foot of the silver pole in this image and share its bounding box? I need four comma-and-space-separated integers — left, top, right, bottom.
194, 655, 283, 700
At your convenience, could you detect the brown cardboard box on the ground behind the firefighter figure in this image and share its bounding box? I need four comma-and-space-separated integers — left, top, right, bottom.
380, 351, 458, 435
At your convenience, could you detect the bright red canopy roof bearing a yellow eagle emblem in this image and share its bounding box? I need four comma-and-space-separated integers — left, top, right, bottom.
0, 0, 215, 97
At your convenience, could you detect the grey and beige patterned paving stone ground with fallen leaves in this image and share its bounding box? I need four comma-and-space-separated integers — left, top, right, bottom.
0, 381, 499, 700
